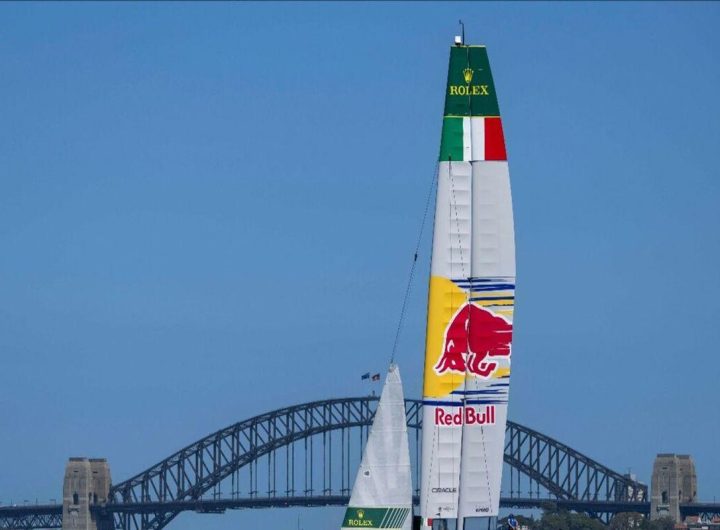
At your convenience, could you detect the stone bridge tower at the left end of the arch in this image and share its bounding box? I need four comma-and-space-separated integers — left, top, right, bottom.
62, 458, 112, 530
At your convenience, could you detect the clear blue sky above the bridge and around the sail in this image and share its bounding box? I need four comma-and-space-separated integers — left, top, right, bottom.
0, 3, 720, 528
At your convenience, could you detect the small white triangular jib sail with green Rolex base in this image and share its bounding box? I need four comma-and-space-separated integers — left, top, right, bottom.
342, 364, 412, 530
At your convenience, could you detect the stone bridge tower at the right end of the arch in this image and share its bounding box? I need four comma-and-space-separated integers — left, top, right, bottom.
650, 454, 697, 523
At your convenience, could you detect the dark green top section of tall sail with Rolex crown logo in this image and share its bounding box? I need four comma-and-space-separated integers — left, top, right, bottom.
445, 46, 500, 116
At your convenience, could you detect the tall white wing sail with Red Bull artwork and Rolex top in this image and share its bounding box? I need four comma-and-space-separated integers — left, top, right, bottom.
420, 37, 515, 530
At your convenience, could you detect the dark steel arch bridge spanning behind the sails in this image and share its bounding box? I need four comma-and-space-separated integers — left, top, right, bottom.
0, 396, 664, 530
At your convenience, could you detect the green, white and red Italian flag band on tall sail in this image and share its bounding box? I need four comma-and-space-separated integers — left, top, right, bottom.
440, 116, 507, 162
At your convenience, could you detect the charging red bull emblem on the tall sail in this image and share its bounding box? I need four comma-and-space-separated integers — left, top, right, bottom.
435, 302, 512, 379
